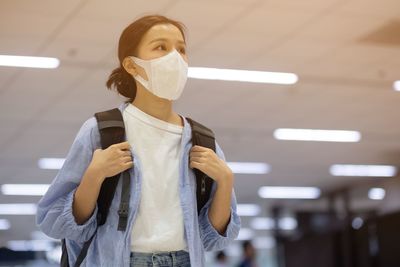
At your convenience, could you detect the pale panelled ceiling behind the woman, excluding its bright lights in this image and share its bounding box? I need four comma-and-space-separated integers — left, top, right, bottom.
0, 0, 400, 251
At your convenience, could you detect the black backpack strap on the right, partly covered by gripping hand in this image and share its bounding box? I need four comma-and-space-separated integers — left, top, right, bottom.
186, 118, 216, 213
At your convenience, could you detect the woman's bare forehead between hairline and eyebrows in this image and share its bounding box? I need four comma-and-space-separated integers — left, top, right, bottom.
142, 24, 185, 44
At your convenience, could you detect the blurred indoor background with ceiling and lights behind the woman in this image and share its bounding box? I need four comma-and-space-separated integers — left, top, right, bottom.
0, 0, 400, 267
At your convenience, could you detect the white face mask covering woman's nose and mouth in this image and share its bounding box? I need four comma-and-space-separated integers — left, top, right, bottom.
130, 49, 188, 100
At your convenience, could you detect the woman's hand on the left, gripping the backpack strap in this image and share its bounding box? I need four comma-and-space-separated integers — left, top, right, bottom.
89, 141, 133, 180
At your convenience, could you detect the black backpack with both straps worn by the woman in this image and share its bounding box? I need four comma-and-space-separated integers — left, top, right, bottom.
60, 108, 215, 267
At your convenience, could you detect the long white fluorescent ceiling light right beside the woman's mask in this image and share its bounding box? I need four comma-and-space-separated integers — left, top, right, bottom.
188, 67, 299, 84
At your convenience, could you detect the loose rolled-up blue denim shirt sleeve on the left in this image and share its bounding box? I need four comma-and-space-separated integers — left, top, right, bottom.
36, 117, 98, 242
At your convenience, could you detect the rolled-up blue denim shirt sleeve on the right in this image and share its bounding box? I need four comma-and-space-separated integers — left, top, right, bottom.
199, 142, 241, 251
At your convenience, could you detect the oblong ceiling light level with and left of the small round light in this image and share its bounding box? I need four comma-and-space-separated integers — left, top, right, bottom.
258, 186, 321, 199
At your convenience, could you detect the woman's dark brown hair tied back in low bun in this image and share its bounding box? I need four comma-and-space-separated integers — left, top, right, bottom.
106, 15, 186, 102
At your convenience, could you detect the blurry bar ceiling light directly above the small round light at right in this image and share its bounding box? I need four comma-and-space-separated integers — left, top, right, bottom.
330, 164, 397, 177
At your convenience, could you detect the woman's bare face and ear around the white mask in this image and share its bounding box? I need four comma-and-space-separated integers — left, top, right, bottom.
124, 24, 188, 80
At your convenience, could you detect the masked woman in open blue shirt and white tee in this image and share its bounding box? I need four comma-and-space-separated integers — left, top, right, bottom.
37, 15, 240, 266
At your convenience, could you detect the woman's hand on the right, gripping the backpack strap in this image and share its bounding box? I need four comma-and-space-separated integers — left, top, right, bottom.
189, 146, 233, 184
